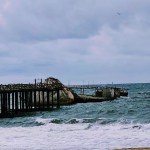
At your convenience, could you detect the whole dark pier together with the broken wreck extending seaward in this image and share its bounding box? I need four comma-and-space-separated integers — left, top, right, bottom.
0, 77, 128, 118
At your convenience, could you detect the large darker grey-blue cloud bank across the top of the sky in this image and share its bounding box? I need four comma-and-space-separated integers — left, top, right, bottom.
0, 0, 149, 41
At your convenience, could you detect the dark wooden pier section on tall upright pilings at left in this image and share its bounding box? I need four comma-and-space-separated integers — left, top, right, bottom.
0, 80, 63, 118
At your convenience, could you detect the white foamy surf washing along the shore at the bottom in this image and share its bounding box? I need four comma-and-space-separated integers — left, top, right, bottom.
0, 121, 150, 150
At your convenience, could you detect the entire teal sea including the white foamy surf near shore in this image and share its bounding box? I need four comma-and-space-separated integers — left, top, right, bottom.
0, 84, 150, 150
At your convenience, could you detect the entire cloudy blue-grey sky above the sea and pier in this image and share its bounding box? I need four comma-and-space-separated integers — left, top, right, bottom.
0, 0, 150, 85
